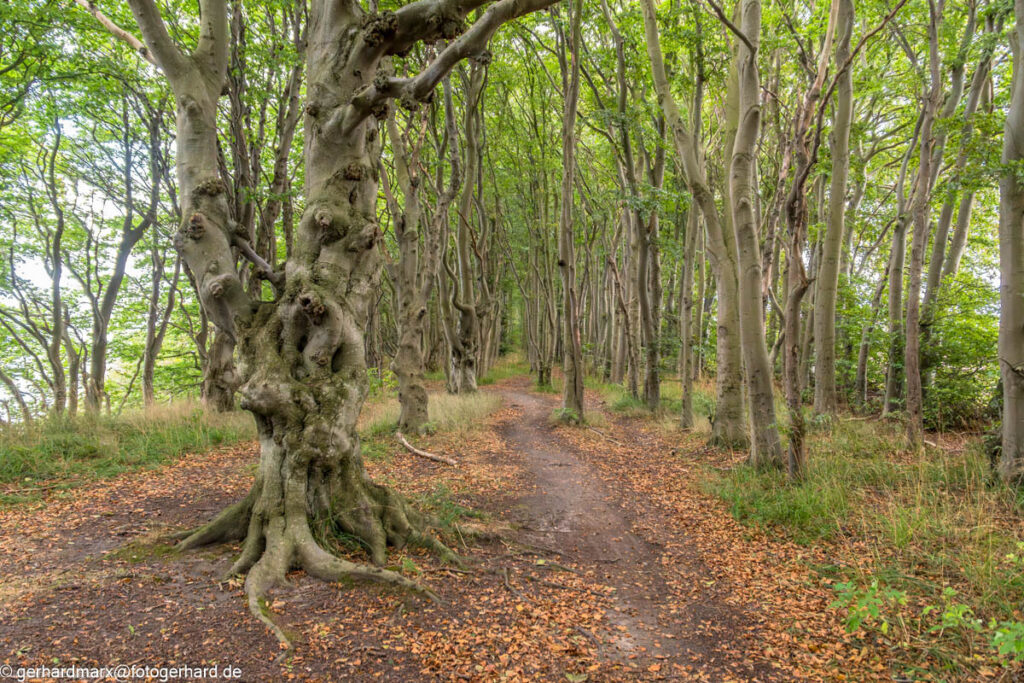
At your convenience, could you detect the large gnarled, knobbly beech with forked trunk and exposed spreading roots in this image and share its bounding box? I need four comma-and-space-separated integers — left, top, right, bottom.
96, 0, 553, 643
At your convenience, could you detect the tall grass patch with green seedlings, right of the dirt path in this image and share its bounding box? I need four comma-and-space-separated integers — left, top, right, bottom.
699, 418, 1024, 677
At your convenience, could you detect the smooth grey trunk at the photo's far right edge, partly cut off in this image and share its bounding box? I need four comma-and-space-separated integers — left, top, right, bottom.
998, 0, 1024, 485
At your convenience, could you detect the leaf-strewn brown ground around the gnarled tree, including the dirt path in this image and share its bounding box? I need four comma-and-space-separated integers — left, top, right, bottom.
0, 378, 929, 681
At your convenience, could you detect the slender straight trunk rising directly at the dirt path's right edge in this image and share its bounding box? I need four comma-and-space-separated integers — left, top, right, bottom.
558, 0, 585, 423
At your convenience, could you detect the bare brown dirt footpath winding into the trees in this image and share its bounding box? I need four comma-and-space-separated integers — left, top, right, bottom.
487, 380, 766, 680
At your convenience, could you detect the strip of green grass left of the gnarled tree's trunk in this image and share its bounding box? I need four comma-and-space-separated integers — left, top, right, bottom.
0, 401, 255, 503
